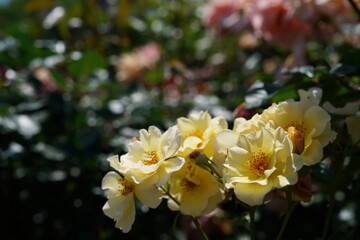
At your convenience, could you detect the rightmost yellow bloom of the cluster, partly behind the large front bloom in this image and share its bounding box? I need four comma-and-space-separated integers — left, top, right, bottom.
260, 89, 336, 165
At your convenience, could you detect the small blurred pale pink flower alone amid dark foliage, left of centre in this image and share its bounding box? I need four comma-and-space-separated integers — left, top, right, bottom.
116, 42, 161, 81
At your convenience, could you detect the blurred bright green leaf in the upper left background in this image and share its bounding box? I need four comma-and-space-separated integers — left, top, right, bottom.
67, 50, 107, 77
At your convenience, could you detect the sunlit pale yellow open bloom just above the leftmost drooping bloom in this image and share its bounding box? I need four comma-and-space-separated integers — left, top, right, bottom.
114, 126, 184, 186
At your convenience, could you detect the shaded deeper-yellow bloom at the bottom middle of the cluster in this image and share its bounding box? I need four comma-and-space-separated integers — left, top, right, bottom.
168, 160, 223, 216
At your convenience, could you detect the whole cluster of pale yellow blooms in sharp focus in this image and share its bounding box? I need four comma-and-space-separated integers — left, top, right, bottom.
102, 88, 336, 232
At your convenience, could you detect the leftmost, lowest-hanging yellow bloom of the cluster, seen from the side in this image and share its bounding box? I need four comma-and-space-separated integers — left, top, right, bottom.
101, 172, 162, 233
